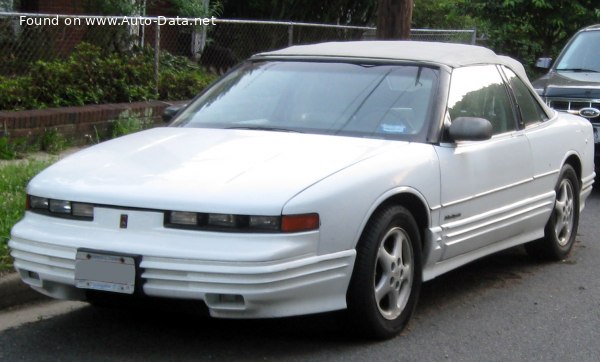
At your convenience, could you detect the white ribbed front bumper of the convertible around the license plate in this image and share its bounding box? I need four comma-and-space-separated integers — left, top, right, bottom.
9, 209, 355, 318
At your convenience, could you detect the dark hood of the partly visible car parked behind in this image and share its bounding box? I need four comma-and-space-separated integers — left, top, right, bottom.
533, 71, 600, 98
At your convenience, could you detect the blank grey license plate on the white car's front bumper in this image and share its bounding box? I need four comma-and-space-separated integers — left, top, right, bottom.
75, 250, 135, 294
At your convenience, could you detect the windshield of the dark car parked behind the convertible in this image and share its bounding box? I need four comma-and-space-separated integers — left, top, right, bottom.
556, 31, 600, 72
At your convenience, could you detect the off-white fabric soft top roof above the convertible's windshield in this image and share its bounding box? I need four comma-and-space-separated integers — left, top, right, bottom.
258, 41, 504, 67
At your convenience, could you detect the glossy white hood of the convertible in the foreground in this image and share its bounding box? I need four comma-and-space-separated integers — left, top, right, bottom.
28, 128, 406, 215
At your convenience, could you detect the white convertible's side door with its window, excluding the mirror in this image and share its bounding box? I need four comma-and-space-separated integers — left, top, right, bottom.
436, 65, 535, 260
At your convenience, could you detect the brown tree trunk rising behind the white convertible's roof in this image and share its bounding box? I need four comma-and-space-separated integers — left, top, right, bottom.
377, 0, 413, 40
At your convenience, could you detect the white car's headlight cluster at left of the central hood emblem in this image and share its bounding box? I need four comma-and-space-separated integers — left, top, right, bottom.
27, 195, 94, 221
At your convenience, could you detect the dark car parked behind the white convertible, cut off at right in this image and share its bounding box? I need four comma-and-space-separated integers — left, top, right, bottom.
533, 24, 600, 164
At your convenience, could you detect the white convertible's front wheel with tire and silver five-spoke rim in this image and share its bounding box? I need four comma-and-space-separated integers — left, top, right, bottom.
346, 206, 422, 339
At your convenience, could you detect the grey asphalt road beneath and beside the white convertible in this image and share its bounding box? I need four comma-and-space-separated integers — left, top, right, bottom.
0, 191, 600, 361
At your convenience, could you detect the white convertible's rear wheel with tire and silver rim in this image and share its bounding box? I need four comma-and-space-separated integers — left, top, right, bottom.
525, 165, 580, 261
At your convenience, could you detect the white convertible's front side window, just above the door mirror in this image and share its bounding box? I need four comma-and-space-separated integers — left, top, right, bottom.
448, 65, 516, 134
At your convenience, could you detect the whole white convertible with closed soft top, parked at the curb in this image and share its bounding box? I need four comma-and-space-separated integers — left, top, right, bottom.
9, 41, 595, 338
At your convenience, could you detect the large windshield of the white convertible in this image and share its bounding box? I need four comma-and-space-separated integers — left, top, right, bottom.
172, 61, 439, 139
